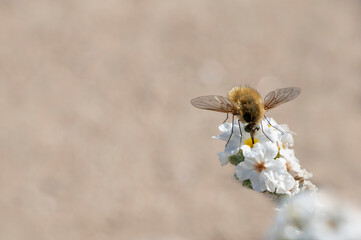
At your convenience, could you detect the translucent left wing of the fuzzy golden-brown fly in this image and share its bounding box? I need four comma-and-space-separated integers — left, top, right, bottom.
191, 95, 234, 113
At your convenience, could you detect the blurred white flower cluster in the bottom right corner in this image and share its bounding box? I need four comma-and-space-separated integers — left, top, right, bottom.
267, 192, 361, 240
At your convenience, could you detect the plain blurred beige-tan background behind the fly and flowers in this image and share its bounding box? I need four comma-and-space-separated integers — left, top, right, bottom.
0, 0, 361, 240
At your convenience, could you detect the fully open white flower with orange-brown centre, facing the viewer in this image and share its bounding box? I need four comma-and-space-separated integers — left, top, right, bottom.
236, 142, 295, 194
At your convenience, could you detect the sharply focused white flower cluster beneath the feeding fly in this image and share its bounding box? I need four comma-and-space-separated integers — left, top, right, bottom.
214, 118, 316, 197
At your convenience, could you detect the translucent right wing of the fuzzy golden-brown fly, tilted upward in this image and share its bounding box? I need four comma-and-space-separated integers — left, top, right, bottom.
263, 87, 301, 111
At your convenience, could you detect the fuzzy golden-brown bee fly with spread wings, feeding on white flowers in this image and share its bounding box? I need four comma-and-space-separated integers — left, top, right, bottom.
191, 86, 301, 145
